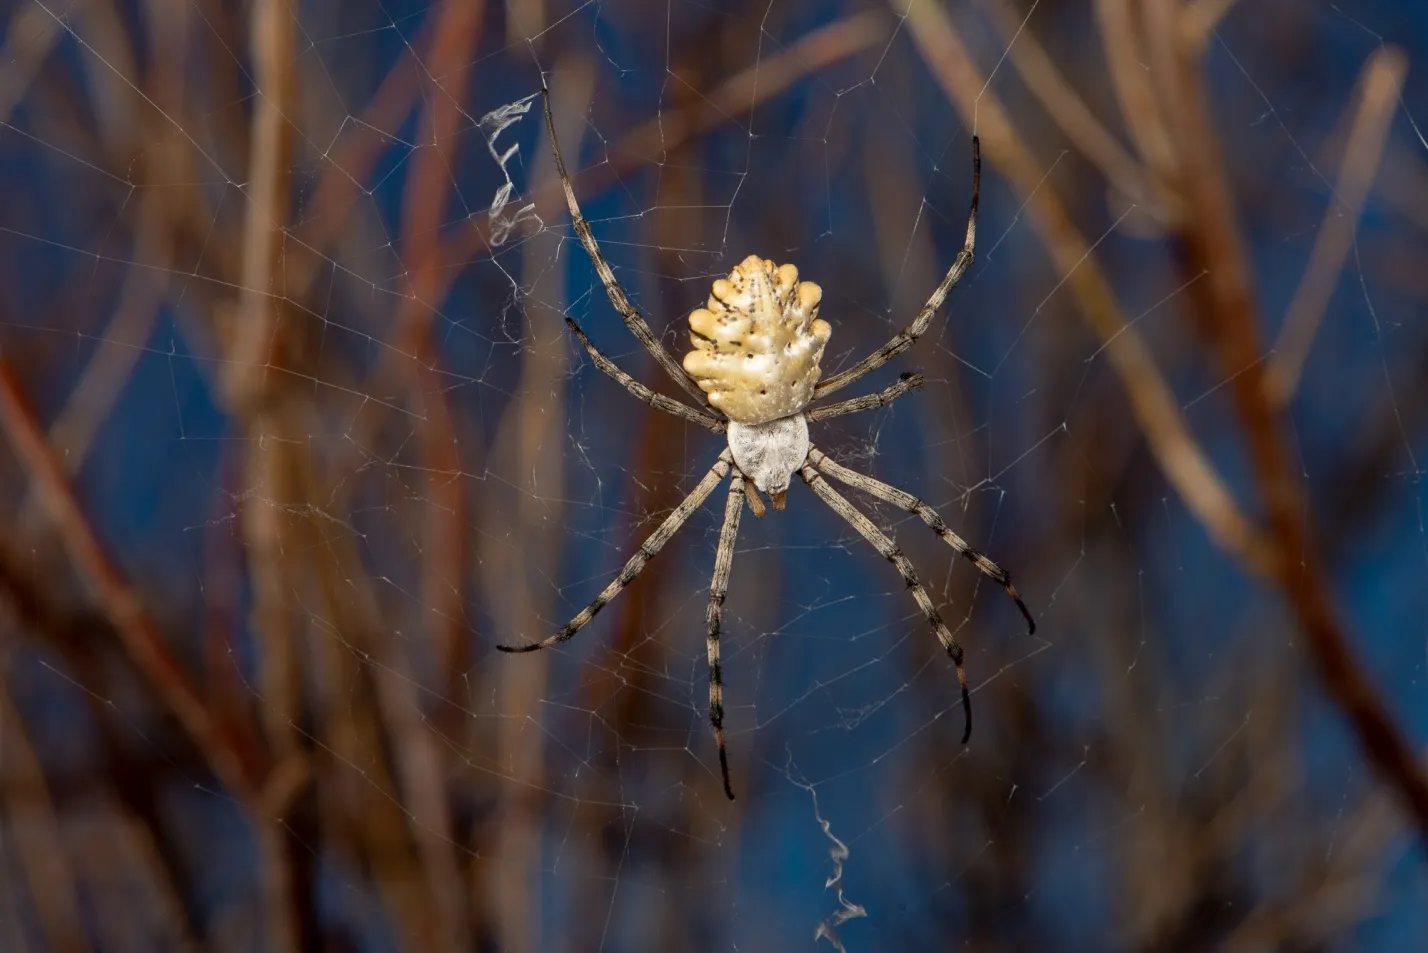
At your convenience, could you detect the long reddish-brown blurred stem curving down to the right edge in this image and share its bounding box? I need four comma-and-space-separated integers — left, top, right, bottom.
1148, 9, 1428, 839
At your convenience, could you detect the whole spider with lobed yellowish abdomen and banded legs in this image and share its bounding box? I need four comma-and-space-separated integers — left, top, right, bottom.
497, 91, 1037, 800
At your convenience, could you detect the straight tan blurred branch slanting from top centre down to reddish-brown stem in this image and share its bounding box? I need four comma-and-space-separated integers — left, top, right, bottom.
907, 0, 1269, 572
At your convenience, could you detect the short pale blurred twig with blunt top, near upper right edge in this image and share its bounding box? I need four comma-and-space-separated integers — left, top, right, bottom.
1264, 47, 1408, 406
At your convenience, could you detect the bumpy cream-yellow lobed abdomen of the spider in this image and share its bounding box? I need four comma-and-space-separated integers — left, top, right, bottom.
684, 254, 833, 424
